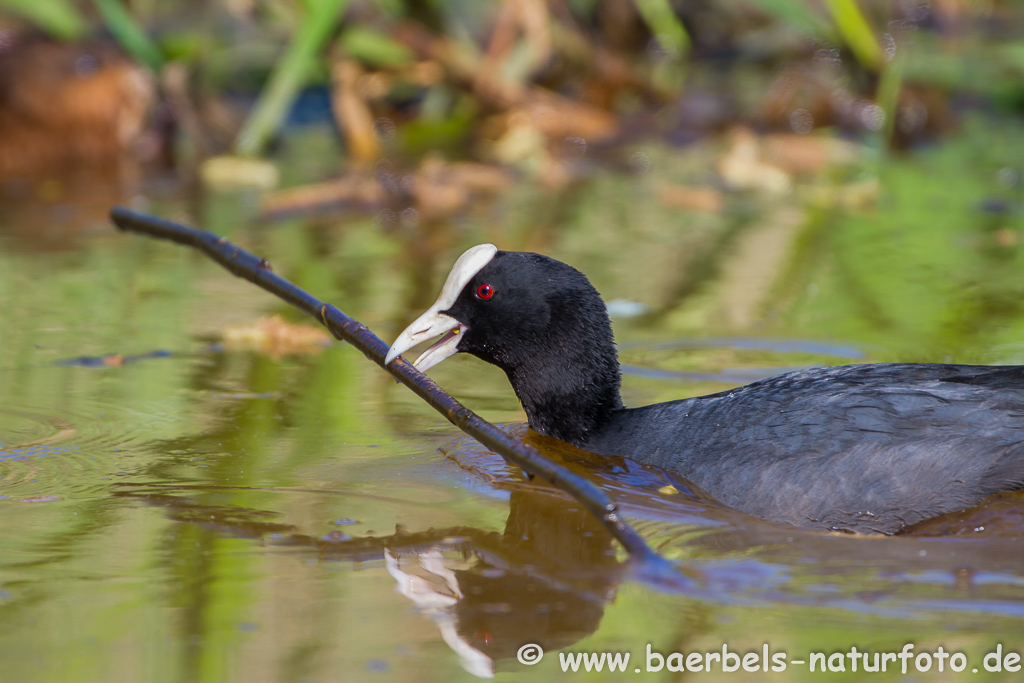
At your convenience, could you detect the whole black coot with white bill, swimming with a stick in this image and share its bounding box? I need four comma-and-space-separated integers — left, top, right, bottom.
387, 245, 1024, 533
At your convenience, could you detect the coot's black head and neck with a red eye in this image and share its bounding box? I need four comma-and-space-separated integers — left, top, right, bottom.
392, 248, 622, 445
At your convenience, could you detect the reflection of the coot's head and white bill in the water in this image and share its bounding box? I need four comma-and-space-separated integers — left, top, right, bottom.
384, 492, 622, 678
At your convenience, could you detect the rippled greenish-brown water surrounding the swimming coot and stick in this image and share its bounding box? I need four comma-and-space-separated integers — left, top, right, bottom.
0, 126, 1024, 683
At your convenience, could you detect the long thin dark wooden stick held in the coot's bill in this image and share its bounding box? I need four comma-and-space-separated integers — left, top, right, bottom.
111, 207, 693, 591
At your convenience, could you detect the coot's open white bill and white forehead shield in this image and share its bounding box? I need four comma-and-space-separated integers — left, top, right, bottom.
384, 245, 498, 373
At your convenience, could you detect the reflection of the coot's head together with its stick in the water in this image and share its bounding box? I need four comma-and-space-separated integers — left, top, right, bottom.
119, 486, 638, 678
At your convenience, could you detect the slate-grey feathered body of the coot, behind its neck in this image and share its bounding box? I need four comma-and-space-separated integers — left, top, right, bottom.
601, 364, 1024, 533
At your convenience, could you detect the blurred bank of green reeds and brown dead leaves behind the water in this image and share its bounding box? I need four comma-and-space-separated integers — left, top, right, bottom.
0, 0, 1024, 178
